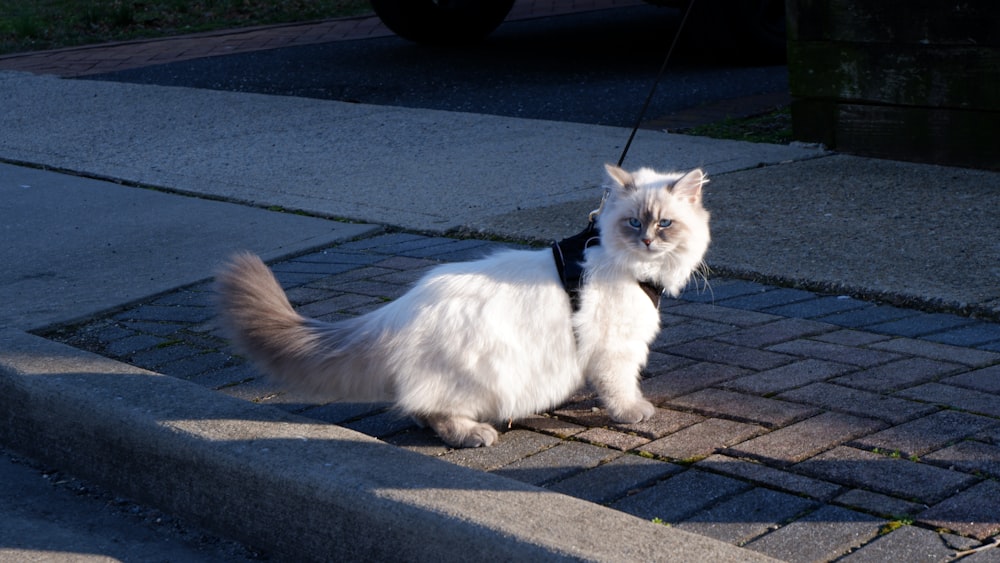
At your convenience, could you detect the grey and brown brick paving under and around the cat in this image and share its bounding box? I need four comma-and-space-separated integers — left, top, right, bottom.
39, 233, 1000, 561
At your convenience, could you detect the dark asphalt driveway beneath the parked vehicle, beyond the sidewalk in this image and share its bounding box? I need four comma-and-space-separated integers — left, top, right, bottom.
87, 5, 788, 126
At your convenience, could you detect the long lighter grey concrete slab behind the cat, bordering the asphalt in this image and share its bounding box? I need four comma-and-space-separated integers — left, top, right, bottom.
0, 72, 823, 234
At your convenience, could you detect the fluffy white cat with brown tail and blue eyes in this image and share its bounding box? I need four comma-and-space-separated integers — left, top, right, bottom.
217, 165, 709, 447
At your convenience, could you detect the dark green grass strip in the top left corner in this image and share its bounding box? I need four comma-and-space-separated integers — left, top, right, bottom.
0, 0, 371, 54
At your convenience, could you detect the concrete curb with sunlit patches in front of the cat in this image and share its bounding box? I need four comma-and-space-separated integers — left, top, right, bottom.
0, 329, 773, 562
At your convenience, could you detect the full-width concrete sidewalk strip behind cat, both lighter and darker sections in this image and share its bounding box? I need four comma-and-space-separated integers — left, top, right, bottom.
0, 68, 1000, 318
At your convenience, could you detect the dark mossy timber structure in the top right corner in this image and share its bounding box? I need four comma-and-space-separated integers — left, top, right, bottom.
786, 0, 1000, 169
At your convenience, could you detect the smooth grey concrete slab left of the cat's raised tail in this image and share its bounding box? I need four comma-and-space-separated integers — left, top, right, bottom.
0, 163, 378, 329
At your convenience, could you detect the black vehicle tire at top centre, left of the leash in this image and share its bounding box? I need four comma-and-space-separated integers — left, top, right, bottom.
371, 0, 514, 45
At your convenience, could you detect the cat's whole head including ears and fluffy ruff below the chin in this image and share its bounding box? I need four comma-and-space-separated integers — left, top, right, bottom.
598, 165, 710, 293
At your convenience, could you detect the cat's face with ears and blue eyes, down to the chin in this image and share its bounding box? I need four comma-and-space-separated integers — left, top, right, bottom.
601, 167, 708, 261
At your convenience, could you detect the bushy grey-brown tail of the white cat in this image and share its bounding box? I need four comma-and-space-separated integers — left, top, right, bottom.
216, 252, 392, 401
